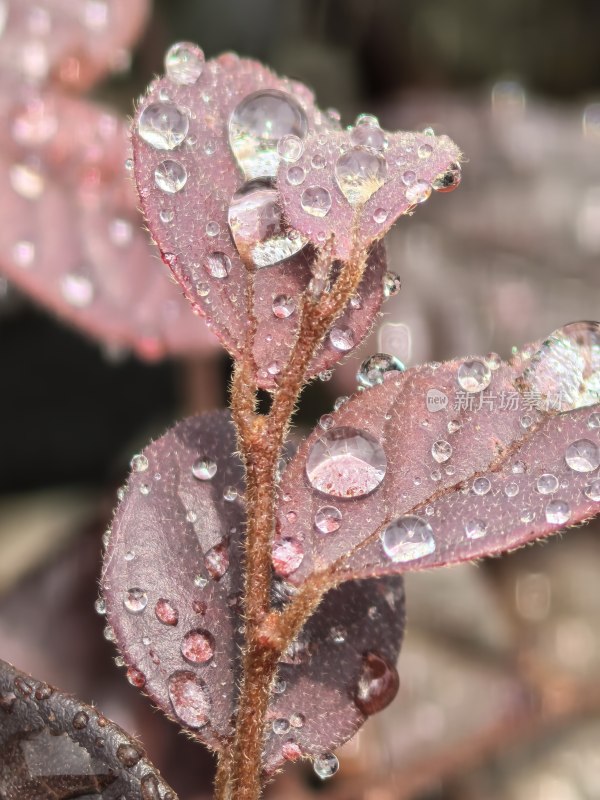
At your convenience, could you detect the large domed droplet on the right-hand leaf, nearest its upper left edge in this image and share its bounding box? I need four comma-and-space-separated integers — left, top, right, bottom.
306, 426, 387, 498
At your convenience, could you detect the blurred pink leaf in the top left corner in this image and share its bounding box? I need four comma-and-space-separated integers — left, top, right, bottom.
0, 0, 148, 90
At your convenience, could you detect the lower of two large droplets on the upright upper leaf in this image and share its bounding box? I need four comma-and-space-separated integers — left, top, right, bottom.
228, 180, 307, 267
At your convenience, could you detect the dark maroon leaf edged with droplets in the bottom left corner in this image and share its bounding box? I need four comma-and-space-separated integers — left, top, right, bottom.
0, 661, 176, 800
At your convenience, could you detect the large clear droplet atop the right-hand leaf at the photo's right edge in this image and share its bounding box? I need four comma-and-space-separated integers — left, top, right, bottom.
519, 322, 600, 411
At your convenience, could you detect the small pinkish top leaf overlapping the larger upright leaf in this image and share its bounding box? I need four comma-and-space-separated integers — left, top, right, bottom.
278, 125, 461, 259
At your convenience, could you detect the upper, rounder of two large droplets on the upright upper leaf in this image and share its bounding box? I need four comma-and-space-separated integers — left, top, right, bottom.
229, 89, 308, 179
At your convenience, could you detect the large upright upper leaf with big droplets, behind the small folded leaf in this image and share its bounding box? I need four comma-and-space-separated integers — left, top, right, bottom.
133, 45, 385, 387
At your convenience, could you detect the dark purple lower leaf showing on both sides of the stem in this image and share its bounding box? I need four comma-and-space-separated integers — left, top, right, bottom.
103, 412, 404, 772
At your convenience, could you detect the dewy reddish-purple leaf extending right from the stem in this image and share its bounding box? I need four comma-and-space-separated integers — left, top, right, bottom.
275, 328, 600, 584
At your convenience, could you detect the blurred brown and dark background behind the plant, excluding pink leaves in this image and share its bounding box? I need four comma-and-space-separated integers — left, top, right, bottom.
0, 0, 600, 800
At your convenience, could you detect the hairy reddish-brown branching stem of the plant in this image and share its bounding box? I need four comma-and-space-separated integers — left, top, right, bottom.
220, 242, 367, 800
